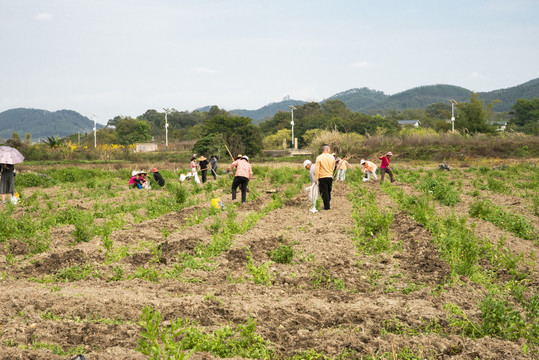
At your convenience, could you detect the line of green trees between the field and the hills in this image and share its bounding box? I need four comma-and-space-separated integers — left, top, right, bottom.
5, 93, 539, 155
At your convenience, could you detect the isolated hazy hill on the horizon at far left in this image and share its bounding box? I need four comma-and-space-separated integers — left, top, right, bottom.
0, 108, 103, 141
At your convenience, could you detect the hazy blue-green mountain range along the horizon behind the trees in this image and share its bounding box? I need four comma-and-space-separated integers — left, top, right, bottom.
0, 78, 539, 141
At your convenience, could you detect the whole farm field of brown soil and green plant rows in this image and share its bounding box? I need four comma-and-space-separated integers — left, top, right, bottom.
0, 162, 539, 360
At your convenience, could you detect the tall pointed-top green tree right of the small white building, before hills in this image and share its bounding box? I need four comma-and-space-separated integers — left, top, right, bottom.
455, 92, 499, 133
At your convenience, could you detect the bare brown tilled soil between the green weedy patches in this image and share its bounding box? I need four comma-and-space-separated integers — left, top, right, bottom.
0, 174, 527, 359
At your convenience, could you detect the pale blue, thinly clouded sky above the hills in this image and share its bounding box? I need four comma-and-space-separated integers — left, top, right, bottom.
0, 0, 539, 124
